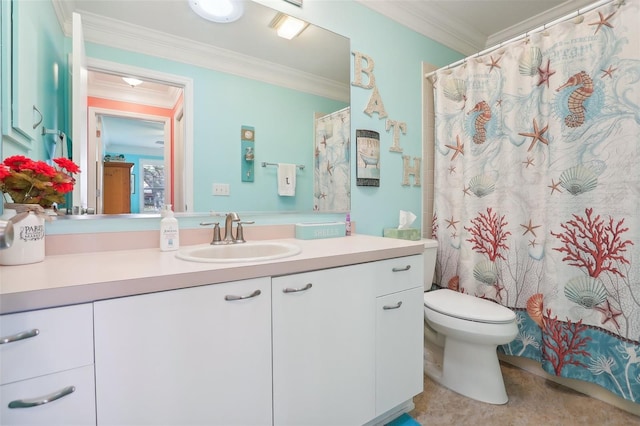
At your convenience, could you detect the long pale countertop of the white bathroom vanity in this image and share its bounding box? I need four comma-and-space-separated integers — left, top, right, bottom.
0, 235, 424, 314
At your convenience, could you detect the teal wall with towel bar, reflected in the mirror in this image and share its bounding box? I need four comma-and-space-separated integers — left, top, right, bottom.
85, 43, 347, 212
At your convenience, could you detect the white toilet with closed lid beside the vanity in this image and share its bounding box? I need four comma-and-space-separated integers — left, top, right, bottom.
424, 240, 518, 404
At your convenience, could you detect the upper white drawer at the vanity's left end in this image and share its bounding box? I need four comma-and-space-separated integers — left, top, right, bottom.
0, 304, 93, 385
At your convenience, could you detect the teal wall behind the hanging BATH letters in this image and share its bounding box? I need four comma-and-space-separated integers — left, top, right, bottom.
272, 0, 462, 235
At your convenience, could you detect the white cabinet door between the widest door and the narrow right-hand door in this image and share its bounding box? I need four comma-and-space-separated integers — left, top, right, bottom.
272, 264, 375, 426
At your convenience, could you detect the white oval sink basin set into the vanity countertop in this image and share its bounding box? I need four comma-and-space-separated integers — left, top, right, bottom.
176, 241, 302, 263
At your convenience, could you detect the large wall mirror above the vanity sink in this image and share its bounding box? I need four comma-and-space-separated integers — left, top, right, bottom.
10, 0, 350, 213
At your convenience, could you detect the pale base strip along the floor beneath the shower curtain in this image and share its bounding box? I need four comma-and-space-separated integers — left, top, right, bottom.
498, 353, 640, 416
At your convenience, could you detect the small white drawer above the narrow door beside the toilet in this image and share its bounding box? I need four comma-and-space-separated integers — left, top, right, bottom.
375, 254, 424, 296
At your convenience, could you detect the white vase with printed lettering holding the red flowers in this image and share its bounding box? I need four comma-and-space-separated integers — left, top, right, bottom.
0, 208, 45, 265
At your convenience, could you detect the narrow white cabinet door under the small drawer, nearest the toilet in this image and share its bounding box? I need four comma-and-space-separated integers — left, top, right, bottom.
376, 286, 424, 415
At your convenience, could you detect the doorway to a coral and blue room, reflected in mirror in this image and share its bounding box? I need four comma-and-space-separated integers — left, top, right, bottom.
88, 70, 184, 214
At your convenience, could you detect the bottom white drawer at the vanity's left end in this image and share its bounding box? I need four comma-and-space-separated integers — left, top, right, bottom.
0, 365, 96, 426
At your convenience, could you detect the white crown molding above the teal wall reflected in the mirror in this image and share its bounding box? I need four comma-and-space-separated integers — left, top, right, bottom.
54, 8, 350, 102
